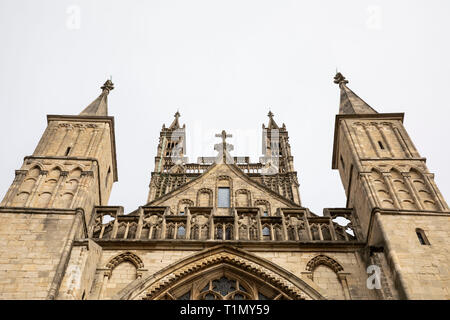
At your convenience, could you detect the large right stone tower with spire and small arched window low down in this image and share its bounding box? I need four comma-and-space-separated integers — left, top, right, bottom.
332, 73, 450, 299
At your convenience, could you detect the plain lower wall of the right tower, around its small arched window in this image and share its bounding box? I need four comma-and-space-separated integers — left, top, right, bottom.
374, 214, 450, 300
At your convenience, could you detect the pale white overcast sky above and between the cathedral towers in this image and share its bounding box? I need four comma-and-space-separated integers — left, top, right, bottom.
0, 0, 450, 214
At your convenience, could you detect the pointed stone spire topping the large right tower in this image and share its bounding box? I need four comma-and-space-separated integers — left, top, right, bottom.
334, 72, 378, 114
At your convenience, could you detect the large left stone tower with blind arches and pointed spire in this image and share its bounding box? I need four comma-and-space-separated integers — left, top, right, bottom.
0, 80, 117, 299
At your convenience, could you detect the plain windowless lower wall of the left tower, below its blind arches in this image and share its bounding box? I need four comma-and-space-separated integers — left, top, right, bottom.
0, 209, 74, 299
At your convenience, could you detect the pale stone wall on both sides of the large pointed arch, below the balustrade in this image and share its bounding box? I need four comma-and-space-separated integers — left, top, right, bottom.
80, 248, 377, 300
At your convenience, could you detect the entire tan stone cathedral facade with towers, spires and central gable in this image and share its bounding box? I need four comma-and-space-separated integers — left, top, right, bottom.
0, 73, 450, 300
